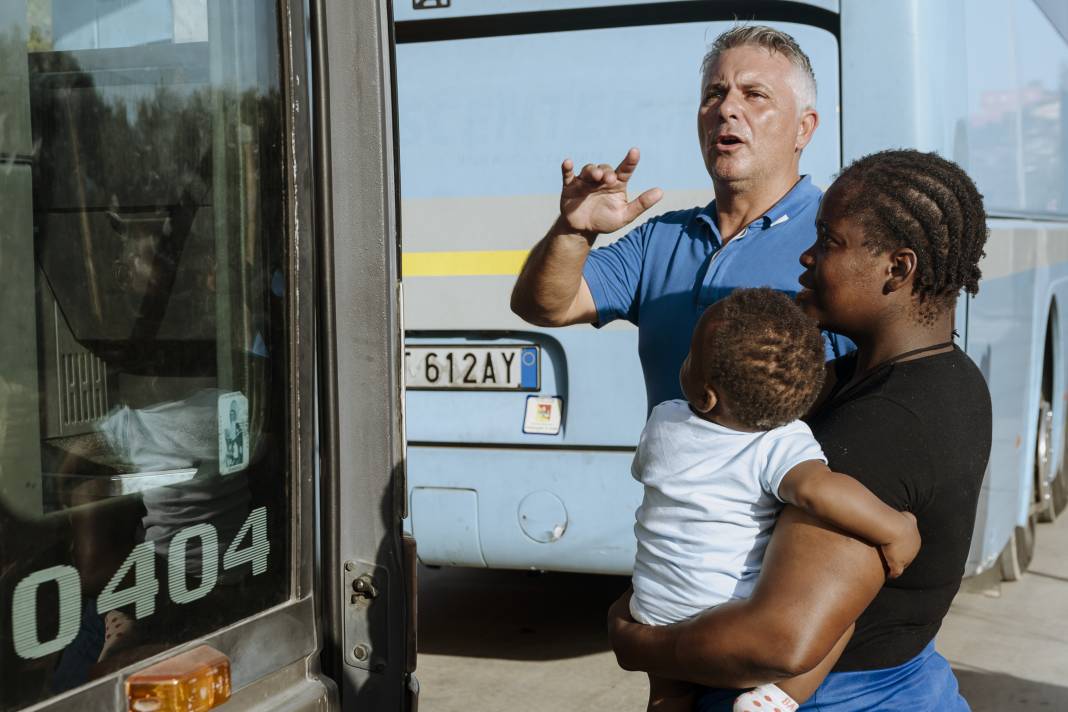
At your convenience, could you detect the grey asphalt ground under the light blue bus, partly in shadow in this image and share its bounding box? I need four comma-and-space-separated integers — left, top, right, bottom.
417, 513, 1068, 712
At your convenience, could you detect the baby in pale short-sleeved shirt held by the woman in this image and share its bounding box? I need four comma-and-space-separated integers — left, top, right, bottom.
630, 288, 920, 712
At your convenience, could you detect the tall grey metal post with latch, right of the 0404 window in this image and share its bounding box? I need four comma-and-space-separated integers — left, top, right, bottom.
313, 0, 418, 711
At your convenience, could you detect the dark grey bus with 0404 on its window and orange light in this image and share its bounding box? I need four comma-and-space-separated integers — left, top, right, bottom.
0, 0, 418, 712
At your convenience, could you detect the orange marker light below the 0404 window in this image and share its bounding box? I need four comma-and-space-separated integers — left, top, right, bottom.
126, 645, 230, 712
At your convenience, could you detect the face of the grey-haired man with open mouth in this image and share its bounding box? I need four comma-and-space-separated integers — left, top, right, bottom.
697, 46, 818, 183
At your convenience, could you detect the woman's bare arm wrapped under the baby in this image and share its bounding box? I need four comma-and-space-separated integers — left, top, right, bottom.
609, 507, 885, 687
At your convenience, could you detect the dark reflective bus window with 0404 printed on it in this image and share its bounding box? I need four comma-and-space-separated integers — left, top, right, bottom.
0, 0, 293, 710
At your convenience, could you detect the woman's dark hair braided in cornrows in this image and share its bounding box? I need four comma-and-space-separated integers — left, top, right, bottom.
836, 149, 987, 321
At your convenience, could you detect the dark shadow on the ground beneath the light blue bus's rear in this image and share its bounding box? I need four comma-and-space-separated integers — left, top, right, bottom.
419, 566, 630, 661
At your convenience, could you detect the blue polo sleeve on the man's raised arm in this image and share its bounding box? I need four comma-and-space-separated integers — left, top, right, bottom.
582, 221, 651, 328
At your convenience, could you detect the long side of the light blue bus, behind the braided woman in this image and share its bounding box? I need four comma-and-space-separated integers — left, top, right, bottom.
841, 0, 1068, 573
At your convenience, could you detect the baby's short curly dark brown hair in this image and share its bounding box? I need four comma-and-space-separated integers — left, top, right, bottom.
702, 287, 824, 430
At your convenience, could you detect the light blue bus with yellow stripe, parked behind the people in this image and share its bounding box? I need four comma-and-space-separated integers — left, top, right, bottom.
395, 0, 1068, 580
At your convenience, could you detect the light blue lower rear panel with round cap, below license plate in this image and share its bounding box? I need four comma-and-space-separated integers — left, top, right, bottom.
406, 446, 642, 574
